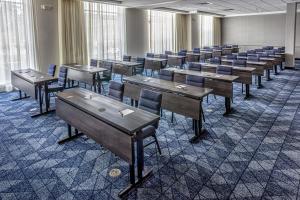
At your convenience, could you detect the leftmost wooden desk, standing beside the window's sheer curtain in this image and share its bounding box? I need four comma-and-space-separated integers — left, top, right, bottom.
11, 69, 57, 117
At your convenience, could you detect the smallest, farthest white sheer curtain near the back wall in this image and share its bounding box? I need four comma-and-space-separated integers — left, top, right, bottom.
199, 15, 213, 47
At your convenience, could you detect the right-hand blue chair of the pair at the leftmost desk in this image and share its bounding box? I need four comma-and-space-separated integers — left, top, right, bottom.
44, 66, 68, 104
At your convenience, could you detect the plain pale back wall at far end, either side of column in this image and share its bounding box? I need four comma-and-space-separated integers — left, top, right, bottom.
222, 13, 300, 58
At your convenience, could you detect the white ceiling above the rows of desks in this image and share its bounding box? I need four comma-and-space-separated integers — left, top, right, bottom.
102, 0, 299, 16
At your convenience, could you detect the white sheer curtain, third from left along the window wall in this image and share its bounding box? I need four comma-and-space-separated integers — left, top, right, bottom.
149, 10, 176, 53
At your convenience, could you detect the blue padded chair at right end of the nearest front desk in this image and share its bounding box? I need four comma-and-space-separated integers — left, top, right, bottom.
138, 89, 162, 155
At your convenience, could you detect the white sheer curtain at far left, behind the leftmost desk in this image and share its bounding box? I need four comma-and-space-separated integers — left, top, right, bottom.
0, 0, 37, 91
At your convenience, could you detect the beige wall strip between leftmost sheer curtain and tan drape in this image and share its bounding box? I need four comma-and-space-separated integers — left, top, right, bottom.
34, 0, 59, 72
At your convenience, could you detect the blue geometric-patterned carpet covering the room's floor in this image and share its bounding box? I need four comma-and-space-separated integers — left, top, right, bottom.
0, 65, 300, 200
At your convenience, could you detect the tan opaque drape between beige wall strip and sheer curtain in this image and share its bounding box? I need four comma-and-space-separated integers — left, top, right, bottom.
59, 0, 88, 64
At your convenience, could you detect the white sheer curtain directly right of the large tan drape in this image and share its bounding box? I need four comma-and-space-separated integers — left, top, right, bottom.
84, 2, 126, 59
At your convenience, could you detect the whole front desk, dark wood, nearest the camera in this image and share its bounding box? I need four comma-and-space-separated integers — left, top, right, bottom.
56, 88, 160, 197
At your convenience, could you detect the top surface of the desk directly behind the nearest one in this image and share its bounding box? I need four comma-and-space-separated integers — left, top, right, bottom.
123, 75, 213, 100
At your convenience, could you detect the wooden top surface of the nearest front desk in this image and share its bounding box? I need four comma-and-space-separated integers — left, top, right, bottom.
57, 88, 160, 135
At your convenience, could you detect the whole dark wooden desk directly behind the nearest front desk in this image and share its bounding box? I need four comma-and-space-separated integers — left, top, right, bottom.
124, 75, 213, 143
